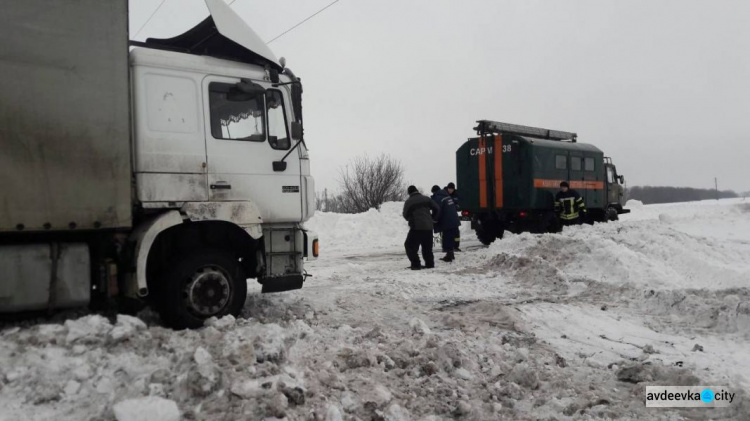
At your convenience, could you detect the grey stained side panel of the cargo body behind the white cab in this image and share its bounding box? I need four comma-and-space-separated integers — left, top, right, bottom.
0, 0, 131, 232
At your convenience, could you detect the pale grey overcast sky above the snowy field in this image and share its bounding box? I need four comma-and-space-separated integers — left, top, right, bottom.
130, 0, 750, 191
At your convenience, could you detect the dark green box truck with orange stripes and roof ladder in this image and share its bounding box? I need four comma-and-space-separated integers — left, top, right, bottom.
456, 120, 629, 244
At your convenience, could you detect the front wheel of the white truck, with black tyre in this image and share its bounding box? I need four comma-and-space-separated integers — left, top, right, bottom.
156, 250, 247, 329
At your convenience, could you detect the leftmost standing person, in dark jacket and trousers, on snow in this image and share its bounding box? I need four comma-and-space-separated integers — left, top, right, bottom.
403, 186, 440, 270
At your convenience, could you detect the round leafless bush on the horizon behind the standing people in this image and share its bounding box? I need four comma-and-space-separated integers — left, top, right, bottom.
339, 154, 407, 213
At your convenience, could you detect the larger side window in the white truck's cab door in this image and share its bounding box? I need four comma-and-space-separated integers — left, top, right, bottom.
209, 82, 266, 142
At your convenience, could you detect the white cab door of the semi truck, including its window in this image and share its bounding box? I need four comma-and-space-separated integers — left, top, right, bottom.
203, 76, 302, 222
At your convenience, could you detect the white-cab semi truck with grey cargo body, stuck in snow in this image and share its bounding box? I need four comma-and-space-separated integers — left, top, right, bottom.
0, 0, 319, 328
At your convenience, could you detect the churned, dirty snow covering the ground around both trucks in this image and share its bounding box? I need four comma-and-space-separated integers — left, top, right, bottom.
0, 199, 750, 421
